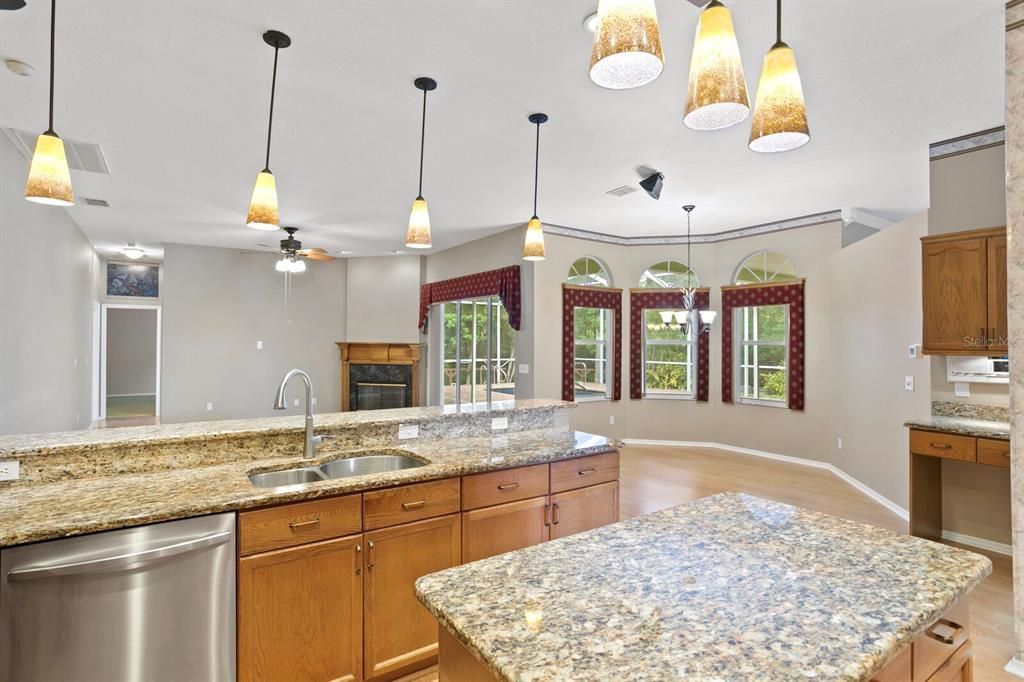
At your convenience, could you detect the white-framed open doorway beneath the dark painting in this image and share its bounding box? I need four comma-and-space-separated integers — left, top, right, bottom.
96, 303, 161, 427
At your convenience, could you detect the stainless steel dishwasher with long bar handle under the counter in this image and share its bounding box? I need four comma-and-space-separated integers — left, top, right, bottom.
0, 512, 234, 682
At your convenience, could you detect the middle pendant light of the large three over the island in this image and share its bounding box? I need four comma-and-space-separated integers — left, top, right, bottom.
683, 0, 751, 130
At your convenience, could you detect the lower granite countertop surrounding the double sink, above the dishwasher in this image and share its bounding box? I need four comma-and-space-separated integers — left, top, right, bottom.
0, 428, 620, 547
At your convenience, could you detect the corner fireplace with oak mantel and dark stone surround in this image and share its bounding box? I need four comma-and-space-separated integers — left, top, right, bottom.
337, 342, 420, 412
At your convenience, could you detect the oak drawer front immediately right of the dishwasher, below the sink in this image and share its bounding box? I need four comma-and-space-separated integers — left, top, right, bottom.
239, 495, 362, 556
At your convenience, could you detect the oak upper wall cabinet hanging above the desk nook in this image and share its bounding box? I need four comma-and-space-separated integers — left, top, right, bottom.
922, 227, 1007, 355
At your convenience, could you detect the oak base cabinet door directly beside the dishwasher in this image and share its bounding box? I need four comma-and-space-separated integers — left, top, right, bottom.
238, 536, 362, 682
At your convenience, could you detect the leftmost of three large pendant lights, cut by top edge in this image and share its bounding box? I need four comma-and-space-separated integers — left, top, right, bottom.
590, 0, 665, 90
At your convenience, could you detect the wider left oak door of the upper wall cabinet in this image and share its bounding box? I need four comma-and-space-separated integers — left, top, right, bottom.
922, 238, 989, 354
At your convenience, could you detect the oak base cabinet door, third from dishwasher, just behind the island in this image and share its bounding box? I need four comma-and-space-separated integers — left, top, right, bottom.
462, 497, 549, 563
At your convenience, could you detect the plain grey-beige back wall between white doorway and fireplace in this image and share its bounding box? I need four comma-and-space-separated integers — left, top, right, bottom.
161, 244, 347, 423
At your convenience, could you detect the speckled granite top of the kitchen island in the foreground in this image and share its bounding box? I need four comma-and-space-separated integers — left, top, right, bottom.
416, 493, 991, 682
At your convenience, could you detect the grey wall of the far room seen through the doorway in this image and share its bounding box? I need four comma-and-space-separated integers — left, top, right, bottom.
105, 308, 157, 396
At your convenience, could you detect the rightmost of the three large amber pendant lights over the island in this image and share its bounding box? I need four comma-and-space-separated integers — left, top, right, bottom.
750, 0, 811, 152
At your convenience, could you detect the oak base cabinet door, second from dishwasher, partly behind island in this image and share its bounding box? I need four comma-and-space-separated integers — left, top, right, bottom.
364, 514, 461, 678
